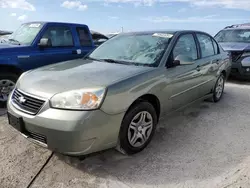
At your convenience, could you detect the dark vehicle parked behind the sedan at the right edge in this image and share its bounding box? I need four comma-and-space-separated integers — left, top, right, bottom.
215, 23, 250, 78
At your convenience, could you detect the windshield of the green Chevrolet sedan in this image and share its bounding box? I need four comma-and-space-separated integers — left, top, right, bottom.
88, 33, 173, 66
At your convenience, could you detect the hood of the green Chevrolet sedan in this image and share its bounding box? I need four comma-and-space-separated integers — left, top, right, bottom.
16, 59, 154, 98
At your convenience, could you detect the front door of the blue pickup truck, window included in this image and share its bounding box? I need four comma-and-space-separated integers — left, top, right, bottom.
19, 26, 81, 70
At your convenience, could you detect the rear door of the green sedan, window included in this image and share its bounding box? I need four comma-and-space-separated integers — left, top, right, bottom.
196, 33, 222, 96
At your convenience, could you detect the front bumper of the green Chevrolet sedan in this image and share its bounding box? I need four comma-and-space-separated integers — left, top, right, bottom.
7, 95, 124, 155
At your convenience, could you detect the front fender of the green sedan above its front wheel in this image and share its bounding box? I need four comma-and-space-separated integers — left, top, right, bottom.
101, 68, 166, 114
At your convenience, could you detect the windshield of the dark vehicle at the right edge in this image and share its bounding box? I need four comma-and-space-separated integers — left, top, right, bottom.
215, 29, 250, 42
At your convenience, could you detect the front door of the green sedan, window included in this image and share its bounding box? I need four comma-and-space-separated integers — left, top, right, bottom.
166, 33, 201, 110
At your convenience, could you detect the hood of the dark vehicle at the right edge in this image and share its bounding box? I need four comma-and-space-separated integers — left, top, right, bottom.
220, 42, 250, 51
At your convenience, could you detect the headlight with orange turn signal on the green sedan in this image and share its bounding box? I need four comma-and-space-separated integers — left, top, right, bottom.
50, 88, 106, 110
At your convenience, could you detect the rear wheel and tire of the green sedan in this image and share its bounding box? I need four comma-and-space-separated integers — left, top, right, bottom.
213, 74, 225, 103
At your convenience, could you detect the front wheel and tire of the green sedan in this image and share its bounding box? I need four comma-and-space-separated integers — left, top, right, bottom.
117, 101, 157, 155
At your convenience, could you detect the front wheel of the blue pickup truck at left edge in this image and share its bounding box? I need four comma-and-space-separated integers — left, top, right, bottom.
0, 73, 18, 107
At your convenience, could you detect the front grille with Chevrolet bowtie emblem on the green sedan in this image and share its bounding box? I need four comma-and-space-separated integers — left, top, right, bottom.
12, 89, 45, 115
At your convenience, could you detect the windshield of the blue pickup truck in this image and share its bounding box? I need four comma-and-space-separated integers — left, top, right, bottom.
8, 23, 43, 45
